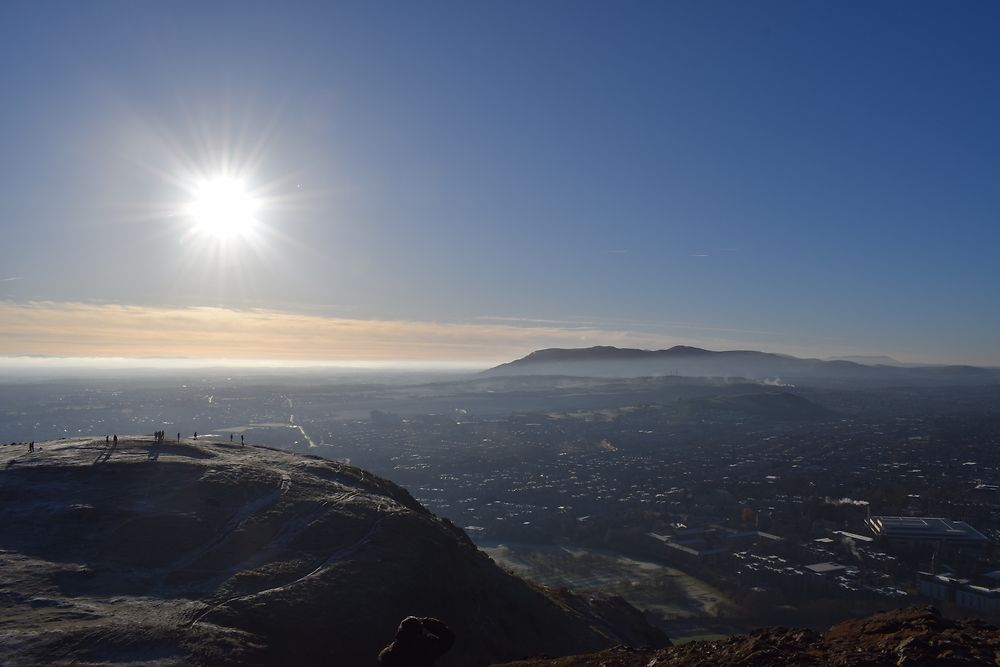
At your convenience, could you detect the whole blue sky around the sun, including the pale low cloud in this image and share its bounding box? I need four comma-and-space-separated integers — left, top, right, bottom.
0, 0, 1000, 365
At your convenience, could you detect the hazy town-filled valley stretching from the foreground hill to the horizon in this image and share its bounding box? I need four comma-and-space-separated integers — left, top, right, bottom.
7, 358, 1000, 642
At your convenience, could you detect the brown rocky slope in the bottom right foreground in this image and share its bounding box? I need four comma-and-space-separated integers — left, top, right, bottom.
494, 607, 1000, 667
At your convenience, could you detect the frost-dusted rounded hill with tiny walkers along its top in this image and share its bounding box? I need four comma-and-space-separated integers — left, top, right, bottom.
0, 436, 667, 667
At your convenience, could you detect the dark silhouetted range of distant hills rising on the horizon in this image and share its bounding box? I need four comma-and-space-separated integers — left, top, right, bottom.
483, 345, 1000, 386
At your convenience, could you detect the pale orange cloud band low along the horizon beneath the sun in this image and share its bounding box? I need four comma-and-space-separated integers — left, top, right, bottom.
0, 301, 704, 363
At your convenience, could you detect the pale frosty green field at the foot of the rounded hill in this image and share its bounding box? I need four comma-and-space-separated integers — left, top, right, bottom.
479, 542, 733, 634
